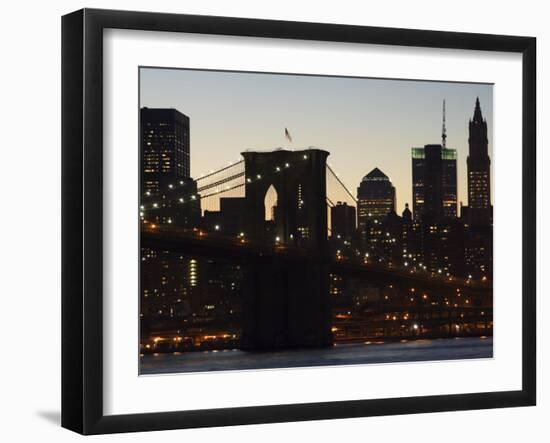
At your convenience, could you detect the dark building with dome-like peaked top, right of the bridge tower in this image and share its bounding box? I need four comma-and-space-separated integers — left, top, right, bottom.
357, 168, 395, 237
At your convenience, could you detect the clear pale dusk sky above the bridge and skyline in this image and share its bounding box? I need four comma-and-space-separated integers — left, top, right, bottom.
140, 68, 493, 212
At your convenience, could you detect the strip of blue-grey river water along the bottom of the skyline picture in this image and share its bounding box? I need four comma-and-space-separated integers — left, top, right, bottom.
140, 337, 493, 374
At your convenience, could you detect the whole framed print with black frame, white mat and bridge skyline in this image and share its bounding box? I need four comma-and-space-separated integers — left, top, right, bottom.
62, 9, 536, 434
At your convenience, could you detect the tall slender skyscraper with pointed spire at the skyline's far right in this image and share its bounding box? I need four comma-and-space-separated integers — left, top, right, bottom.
464, 98, 493, 226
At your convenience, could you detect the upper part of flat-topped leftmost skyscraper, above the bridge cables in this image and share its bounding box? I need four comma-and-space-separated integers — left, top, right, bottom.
140, 108, 190, 195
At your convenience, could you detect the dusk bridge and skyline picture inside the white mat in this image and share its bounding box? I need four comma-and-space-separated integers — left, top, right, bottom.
135, 66, 496, 375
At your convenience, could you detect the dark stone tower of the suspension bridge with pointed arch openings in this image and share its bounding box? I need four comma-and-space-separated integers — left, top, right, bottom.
242, 149, 332, 349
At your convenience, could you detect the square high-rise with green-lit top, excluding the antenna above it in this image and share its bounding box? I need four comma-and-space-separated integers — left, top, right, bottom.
411, 145, 457, 220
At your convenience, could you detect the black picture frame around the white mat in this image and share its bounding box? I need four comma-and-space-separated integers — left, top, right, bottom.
62, 9, 536, 434
